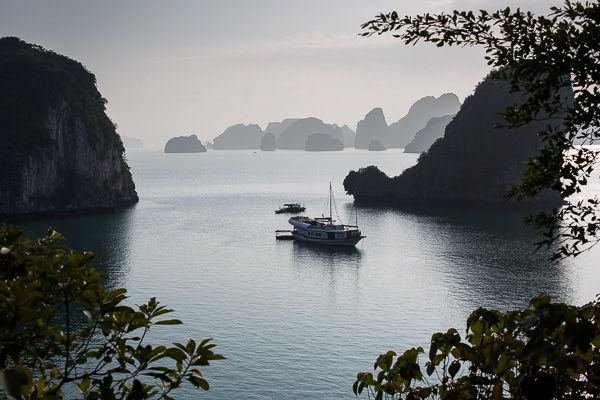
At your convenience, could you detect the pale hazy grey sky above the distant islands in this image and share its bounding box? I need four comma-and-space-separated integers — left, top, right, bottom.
0, 0, 562, 148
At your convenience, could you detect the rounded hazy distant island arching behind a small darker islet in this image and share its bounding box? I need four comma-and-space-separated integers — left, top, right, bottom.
277, 118, 344, 150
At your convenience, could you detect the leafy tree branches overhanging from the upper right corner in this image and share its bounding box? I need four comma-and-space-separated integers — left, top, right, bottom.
362, 1, 600, 259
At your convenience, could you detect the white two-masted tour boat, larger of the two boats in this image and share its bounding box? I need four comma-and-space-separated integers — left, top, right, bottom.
288, 184, 366, 246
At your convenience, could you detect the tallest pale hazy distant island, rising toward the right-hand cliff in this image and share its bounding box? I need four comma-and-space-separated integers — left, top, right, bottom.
383, 93, 460, 149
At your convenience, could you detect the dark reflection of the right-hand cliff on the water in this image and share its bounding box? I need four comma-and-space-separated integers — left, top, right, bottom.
362, 206, 576, 310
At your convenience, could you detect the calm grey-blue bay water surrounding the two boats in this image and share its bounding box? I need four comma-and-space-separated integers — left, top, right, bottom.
16, 149, 600, 399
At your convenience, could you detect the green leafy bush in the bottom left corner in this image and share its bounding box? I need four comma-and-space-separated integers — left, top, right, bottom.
0, 225, 224, 400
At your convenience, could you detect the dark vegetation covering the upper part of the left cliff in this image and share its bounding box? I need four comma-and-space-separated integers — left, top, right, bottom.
0, 37, 118, 154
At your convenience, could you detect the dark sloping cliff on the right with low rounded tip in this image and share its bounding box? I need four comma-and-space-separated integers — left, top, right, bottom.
344, 73, 572, 207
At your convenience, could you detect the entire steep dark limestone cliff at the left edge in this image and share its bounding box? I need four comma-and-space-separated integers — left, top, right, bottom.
0, 37, 138, 220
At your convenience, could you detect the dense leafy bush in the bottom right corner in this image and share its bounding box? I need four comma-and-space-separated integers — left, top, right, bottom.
353, 295, 600, 400
